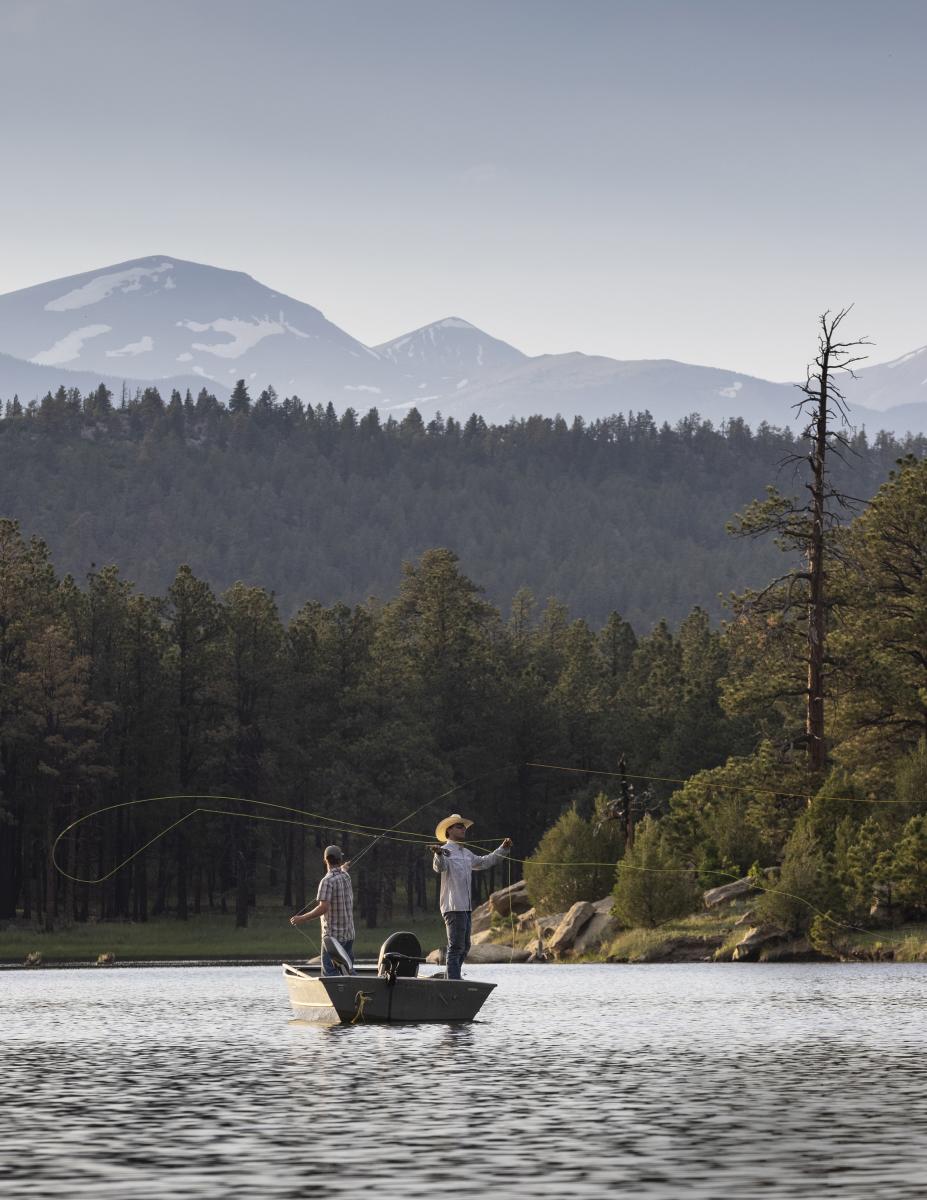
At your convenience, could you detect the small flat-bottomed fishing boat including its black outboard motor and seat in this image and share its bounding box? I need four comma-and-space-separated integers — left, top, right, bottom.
283, 931, 496, 1025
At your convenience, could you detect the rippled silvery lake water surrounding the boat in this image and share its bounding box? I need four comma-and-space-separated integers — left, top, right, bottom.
0, 964, 927, 1200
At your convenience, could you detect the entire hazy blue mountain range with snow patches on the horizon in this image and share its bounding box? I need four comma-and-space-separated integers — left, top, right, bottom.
0, 254, 927, 433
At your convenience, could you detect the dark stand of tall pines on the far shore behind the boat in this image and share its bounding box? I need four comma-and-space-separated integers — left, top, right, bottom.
0, 535, 748, 929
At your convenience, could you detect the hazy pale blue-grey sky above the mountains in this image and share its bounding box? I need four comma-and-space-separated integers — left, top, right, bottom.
0, 0, 927, 378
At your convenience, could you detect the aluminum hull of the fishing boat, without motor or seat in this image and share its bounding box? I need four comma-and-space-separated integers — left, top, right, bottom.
283, 962, 496, 1025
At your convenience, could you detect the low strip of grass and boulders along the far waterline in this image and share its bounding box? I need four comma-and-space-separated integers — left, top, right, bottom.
7, 877, 927, 972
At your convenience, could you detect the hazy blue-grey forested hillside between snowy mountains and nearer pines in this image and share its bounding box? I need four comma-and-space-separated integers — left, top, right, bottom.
0, 384, 925, 632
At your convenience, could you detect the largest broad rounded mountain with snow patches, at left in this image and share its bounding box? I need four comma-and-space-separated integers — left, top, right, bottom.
0, 254, 393, 408
